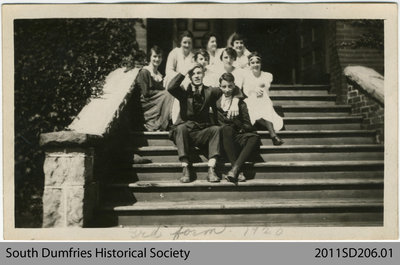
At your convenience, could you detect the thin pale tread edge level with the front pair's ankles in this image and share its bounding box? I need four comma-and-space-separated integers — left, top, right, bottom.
132, 160, 384, 169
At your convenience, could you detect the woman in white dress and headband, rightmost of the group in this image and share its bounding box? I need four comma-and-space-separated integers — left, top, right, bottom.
243, 52, 284, 145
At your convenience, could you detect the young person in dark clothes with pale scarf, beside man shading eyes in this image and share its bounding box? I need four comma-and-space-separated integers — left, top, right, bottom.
216, 73, 260, 182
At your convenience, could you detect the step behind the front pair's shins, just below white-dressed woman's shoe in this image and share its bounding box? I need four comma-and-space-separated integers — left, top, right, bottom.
138, 144, 384, 163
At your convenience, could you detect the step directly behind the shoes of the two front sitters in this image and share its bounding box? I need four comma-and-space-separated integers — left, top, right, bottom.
128, 160, 384, 181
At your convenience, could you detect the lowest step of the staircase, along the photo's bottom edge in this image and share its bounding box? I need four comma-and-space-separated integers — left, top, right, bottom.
103, 198, 383, 226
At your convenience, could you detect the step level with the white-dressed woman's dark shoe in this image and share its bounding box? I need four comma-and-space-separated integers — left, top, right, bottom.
131, 130, 376, 146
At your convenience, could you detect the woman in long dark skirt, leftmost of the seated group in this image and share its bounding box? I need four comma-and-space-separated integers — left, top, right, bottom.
134, 46, 174, 131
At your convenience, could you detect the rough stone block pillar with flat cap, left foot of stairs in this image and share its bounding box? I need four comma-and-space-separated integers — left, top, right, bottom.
41, 132, 98, 227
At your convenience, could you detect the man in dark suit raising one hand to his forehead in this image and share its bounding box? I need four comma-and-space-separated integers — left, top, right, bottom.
168, 64, 242, 183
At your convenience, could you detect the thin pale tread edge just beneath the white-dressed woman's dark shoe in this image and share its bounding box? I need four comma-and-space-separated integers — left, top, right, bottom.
138, 144, 385, 153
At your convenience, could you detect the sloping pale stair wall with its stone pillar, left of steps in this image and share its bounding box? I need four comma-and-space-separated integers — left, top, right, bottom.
40, 68, 138, 227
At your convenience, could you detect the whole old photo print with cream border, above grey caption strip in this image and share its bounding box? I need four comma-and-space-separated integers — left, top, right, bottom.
2, 4, 398, 240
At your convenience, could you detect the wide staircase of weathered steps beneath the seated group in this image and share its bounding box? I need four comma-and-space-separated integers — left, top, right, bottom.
97, 85, 384, 226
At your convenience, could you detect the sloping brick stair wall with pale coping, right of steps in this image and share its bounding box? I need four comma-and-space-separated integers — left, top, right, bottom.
344, 66, 385, 142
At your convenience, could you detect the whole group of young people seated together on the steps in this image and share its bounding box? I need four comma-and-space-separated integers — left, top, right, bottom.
135, 31, 283, 183
